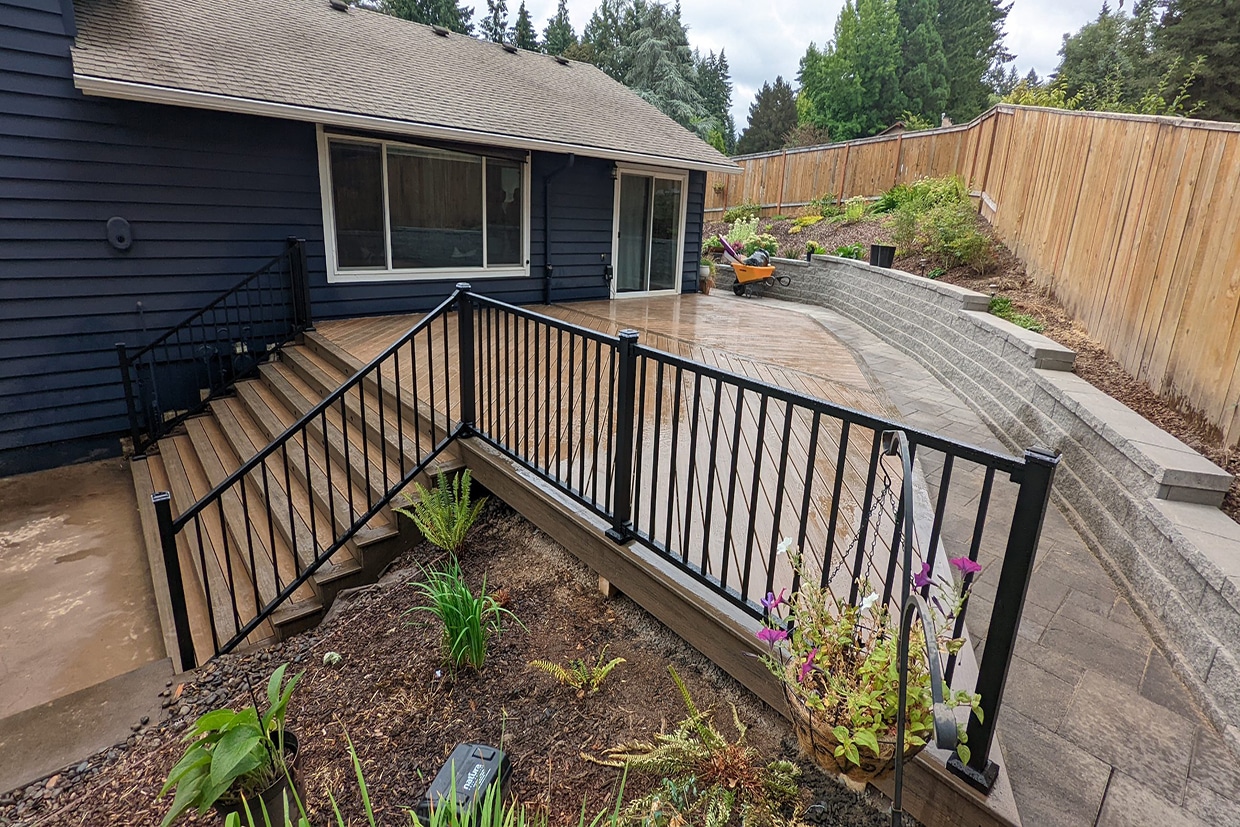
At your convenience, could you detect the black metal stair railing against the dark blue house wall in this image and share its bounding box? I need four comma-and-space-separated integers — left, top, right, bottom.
117, 238, 311, 455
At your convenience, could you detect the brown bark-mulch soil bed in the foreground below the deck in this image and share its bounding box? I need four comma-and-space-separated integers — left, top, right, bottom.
0, 502, 912, 827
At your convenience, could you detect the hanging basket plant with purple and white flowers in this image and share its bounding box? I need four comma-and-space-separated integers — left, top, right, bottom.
758, 539, 981, 786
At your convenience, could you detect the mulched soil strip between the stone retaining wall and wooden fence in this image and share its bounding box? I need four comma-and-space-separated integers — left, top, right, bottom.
706, 216, 1240, 522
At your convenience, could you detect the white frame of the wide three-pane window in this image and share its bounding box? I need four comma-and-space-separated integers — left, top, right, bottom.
316, 124, 531, 284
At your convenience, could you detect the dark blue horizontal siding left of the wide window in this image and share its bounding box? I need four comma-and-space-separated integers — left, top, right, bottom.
0, 0, 322, 475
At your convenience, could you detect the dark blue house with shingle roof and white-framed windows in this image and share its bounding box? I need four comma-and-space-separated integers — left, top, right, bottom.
0, 0, 735, 475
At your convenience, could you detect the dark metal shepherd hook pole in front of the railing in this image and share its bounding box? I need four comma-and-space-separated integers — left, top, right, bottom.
883, 430, 956, 827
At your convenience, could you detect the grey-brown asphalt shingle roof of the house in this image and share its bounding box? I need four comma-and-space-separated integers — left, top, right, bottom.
73, 0, 732, 167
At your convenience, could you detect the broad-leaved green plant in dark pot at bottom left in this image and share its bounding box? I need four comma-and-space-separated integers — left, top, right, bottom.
160, 663, 305, 827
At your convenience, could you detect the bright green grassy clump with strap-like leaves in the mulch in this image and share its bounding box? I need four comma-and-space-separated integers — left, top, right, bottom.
405, 558, 525, 670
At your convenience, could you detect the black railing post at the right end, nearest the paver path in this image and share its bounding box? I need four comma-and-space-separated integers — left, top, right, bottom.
947, 448, 1059, 792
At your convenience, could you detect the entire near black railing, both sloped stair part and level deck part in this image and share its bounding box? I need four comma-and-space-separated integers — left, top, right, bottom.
150, 285, 1058, 790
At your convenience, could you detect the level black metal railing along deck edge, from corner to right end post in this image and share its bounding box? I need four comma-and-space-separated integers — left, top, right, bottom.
463, 306, 1058, 789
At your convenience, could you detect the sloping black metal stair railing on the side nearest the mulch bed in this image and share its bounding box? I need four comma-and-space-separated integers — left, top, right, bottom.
155, 291, 463, 668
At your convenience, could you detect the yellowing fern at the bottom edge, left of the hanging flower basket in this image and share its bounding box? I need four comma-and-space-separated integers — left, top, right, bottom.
601, 666, 800, 827
